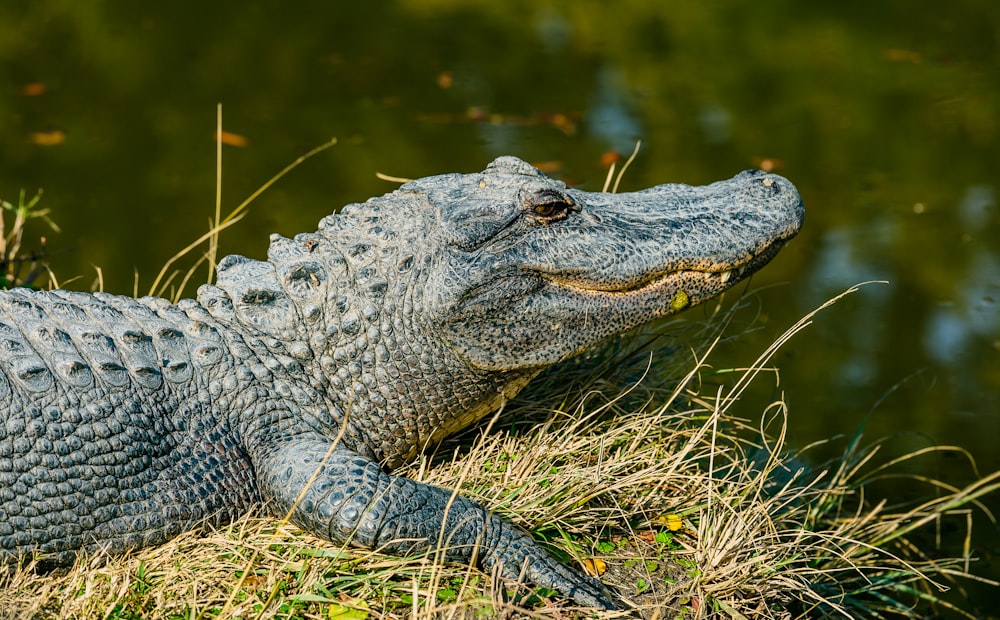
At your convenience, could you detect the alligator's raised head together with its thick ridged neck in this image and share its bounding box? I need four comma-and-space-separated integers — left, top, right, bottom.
199, 157, 803, 463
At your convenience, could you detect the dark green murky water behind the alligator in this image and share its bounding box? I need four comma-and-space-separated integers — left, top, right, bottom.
0, 0, 1000, 609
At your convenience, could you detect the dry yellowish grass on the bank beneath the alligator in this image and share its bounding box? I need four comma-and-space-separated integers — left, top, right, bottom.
0, 151, 1000, 619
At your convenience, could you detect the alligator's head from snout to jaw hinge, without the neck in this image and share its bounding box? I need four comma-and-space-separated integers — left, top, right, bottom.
400, 157, 804, 371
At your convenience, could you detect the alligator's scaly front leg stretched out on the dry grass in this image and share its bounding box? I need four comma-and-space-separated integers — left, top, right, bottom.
257, 439, 615, 609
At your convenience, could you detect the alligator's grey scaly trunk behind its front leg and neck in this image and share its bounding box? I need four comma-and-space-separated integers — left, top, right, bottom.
0, 289, 256, 563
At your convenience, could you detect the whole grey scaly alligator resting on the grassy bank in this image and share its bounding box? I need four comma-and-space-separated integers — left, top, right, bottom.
0, 157, 804, 608
